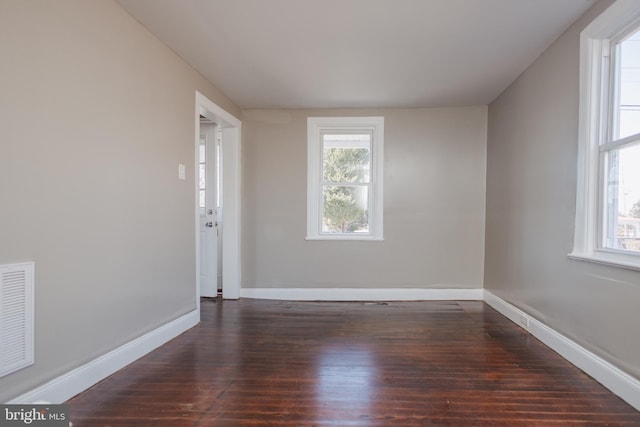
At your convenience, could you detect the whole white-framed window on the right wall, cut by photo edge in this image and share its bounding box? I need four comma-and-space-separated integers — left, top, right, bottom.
570, 0, 640, 269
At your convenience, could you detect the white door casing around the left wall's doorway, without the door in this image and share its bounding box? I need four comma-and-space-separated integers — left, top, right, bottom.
193, 91, 242, 302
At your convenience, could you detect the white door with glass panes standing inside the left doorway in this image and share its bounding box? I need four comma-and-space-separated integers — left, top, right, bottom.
199, 123, 222, 297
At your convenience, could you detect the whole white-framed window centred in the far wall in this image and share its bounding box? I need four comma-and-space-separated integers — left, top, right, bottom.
307, 117, 384, 240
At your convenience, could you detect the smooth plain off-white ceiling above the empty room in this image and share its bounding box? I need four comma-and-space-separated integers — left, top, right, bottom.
118, 0, 595, 108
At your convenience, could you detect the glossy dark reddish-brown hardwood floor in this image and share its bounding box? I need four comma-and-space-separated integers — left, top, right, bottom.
68, 299, 640, 427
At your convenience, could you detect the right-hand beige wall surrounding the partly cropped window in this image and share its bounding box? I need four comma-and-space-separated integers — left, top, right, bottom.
485, 1, 640, 378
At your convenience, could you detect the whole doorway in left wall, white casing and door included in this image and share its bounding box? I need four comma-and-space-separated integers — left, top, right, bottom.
195, 92, 241, 307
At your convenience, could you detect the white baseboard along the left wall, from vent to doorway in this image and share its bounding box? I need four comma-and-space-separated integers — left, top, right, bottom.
7, 309, 200, 404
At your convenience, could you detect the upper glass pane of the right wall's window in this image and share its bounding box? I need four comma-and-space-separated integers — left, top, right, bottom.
614, 31, 640, 139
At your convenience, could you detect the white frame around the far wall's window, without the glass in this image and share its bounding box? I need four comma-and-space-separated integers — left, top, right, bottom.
306, 117, 384, 240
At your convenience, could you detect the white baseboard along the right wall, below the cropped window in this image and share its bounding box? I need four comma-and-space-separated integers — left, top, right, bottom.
484, 290, 640, 411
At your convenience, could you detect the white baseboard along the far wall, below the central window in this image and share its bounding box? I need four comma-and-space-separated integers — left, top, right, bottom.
240, 288, 483, 301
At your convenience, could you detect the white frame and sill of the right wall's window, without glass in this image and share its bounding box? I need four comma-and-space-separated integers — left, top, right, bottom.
569, 0, 640, 270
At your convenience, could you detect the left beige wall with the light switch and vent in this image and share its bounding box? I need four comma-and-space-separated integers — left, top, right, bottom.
0, 0, 239, 401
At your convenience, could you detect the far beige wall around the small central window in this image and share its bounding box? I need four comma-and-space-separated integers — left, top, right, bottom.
242, 107, 487, 288
